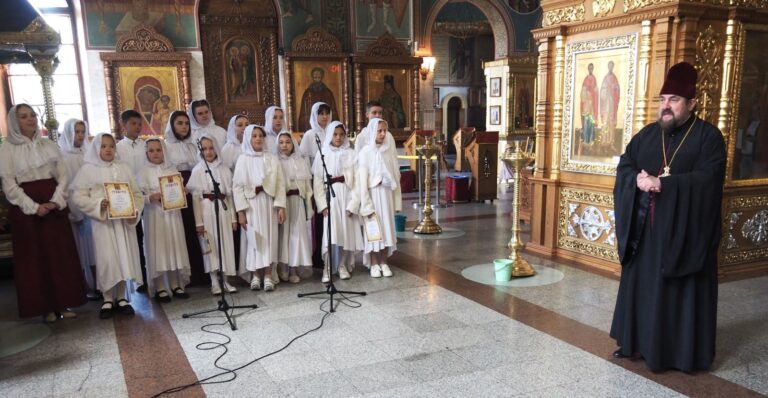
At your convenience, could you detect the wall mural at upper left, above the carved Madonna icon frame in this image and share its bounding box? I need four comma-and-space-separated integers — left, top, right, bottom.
82, 0, 199, 49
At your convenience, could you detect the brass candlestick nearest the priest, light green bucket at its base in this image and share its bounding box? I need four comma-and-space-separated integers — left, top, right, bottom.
501, 141, 536, 277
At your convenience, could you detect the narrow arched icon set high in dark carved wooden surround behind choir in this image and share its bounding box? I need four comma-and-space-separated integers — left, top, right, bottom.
224, 39, 258, 102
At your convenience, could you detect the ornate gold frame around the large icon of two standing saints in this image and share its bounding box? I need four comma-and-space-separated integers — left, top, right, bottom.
560, 33, 639, 175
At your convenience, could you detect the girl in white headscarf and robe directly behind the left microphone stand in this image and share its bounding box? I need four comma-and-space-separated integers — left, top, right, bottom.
187, 134, 237, 295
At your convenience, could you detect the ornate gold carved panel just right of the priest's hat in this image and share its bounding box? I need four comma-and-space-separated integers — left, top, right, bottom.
694, 25, 724, 124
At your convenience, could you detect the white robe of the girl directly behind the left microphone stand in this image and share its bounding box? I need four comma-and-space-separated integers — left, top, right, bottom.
188, 162, 237, 276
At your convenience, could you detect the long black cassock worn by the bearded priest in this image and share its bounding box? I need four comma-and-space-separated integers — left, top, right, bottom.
611, 114, 726, 372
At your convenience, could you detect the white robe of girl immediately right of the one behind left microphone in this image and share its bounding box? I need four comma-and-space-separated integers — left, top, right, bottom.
232, 152, 285, 280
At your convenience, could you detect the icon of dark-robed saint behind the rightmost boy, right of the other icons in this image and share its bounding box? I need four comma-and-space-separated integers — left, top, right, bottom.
365, 68, 412, 131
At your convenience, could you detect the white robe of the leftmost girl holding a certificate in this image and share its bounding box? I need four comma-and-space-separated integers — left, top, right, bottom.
72, 162, 144, 292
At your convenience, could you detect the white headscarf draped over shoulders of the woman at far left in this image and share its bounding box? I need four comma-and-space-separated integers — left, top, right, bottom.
0, 104, 61, 177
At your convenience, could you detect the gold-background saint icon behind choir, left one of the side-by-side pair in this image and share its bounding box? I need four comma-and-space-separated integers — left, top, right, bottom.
292, 60, 344, 132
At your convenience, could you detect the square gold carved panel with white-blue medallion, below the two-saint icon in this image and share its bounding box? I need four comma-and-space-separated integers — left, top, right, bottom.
557, 187, 619, 262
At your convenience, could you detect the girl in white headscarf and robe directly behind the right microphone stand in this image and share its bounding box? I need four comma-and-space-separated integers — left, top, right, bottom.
312, 122, 363, 282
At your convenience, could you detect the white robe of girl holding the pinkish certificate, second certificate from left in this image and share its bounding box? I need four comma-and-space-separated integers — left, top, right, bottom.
138, 165, 190, 293
